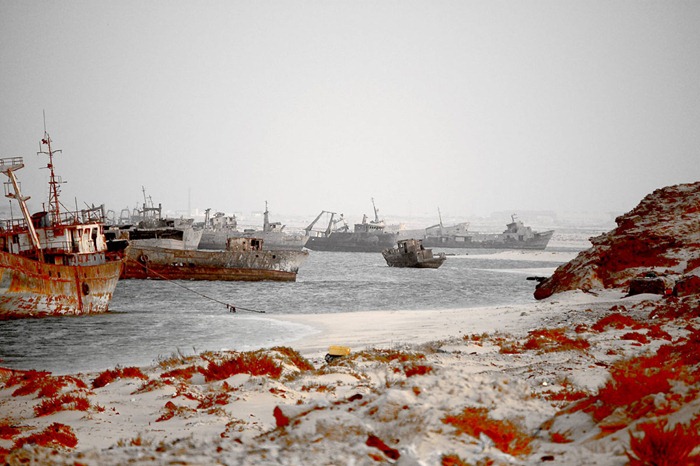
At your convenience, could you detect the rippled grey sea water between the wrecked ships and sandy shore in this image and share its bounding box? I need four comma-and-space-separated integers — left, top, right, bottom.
0, 250, 576, 374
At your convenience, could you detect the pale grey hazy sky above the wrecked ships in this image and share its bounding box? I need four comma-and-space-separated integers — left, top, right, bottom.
0, 0, 700, 221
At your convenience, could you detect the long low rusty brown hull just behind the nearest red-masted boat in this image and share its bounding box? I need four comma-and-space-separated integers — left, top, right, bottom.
121, 245, 309, 281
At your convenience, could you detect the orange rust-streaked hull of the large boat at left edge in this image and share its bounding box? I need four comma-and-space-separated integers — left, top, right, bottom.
0, 252, 122, 320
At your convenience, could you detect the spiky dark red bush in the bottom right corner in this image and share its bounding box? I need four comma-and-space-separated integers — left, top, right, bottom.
626, 419, 700, 466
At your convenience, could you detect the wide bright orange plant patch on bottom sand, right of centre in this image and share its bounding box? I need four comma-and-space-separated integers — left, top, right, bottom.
442, 407, 532, 456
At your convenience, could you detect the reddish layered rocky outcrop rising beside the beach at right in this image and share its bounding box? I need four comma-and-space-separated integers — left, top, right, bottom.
535, 182, 700, 299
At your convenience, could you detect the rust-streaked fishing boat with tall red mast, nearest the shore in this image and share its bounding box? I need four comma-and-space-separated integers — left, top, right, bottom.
0, 132, 125, 319
